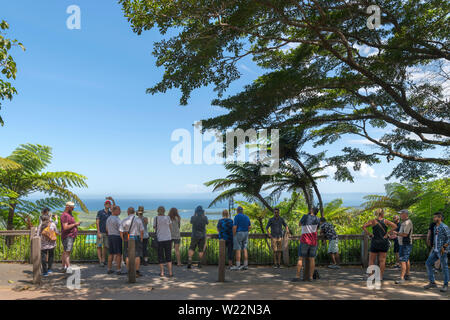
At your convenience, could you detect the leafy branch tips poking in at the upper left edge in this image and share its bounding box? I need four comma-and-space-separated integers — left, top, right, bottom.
0, 20, 25, 126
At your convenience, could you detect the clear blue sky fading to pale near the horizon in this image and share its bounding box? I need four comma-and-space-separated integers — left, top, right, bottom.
0, 0, 406, 196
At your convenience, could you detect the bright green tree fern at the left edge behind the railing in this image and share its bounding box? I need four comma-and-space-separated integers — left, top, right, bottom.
0, 144, 88, 230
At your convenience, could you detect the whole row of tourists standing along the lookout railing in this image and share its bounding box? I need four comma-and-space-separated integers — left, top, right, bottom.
38, 197, 450, 292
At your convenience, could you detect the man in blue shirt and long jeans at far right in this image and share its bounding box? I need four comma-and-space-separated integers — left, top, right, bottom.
424, 212, 450, 292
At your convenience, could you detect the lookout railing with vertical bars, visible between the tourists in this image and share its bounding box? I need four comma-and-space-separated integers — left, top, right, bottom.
0, 230, 429, 265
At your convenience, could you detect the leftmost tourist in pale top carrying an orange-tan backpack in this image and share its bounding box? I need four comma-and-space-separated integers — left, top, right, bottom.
38, 215, 58, 277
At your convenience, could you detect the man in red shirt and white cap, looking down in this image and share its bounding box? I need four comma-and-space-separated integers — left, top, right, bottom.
61, 201, 81, 272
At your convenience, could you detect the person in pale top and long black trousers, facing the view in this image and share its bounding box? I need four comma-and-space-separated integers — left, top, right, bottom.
153, 207, 173, 277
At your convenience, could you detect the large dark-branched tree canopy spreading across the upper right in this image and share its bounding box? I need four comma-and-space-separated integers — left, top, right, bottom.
119, 0, 450, 178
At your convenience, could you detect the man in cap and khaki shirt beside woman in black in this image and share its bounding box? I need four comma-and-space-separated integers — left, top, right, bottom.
394, 209, 413, 284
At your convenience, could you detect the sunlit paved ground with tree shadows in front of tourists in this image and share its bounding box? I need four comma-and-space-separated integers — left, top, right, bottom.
0, 264, 450, 300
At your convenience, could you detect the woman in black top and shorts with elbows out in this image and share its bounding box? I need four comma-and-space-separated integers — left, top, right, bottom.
363, 209, 397, 281
